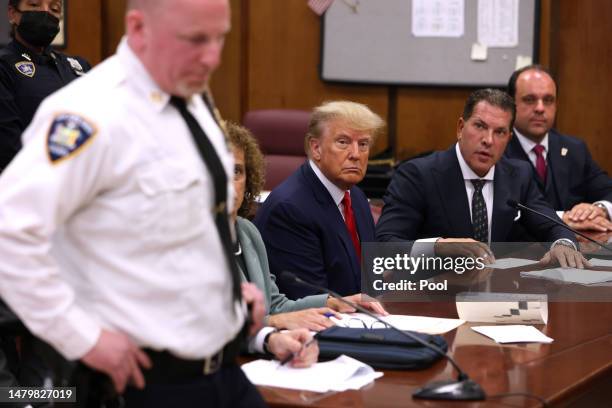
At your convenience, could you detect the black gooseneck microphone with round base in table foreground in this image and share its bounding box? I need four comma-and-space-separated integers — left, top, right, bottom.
282, 271, 486, 401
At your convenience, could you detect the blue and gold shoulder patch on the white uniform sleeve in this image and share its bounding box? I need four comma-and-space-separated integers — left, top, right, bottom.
47, 113, 97, 164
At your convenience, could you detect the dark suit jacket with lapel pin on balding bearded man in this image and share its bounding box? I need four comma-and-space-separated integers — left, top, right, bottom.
504, 129, 612, 211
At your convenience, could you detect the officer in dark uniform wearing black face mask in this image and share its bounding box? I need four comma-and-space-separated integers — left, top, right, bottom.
0, 0, 90, 398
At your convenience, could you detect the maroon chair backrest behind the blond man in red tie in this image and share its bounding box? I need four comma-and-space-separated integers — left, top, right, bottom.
243, 109, 310, 190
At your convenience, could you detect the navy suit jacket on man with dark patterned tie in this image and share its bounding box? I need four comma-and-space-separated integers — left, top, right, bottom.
376, 146, 575, 242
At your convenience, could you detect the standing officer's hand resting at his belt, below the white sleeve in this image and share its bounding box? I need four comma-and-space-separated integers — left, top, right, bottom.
81, 330, 152, 394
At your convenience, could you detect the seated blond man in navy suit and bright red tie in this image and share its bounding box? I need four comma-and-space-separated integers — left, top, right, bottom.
255, 101, 384, 299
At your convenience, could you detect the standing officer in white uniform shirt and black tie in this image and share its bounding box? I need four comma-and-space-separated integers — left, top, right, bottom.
0, 0, 316, 407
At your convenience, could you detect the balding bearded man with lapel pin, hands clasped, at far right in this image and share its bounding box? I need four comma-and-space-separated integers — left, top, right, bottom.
505, 65, 612, 232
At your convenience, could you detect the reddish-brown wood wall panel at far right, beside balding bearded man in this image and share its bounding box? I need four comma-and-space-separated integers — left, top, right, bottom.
554, 0, 612, 173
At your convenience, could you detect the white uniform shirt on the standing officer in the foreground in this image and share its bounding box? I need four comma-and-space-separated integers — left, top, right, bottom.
0, 39, 244, 359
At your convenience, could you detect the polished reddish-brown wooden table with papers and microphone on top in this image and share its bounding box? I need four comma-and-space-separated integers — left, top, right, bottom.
253, 234, 612, 408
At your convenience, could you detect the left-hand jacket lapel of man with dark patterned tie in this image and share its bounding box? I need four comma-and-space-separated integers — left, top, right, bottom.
432, 145, 474, 237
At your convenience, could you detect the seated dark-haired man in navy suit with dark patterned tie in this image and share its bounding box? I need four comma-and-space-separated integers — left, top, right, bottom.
376, 89, 586, 267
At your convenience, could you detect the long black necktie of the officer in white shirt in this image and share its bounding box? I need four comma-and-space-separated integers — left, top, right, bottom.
170, 96, 242, 304
